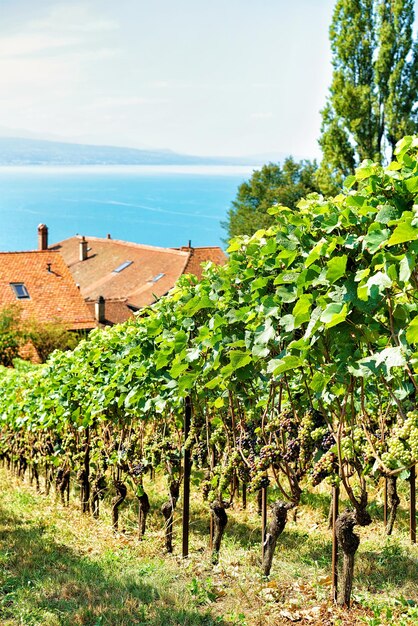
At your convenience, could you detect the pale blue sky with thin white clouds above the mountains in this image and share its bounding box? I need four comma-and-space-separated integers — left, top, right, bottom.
0, 0, 414, 157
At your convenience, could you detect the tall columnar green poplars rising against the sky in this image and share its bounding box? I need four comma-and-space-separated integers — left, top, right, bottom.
318, 0, 418, 194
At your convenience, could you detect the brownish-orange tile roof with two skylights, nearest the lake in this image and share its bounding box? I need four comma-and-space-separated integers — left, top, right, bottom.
51, 236, 225, 308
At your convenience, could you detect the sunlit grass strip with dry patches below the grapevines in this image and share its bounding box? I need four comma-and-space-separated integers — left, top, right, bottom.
0, 469, 418, 626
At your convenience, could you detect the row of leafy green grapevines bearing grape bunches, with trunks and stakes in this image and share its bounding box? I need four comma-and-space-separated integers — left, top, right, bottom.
0, 137, 418, 620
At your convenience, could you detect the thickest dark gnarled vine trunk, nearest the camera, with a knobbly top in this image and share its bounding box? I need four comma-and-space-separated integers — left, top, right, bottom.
335, 509, 372, 608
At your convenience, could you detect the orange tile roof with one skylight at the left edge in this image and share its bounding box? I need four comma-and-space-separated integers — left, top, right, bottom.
0, 250, 97, 330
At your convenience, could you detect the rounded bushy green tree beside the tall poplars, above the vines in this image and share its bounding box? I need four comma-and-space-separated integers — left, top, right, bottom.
223, 157, 319, 238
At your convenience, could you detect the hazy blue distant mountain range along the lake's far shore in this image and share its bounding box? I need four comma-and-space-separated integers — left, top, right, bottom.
0, 137, 286, 166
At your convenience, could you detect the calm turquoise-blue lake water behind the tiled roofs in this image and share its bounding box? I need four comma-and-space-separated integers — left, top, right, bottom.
0, 166, 255, 251
